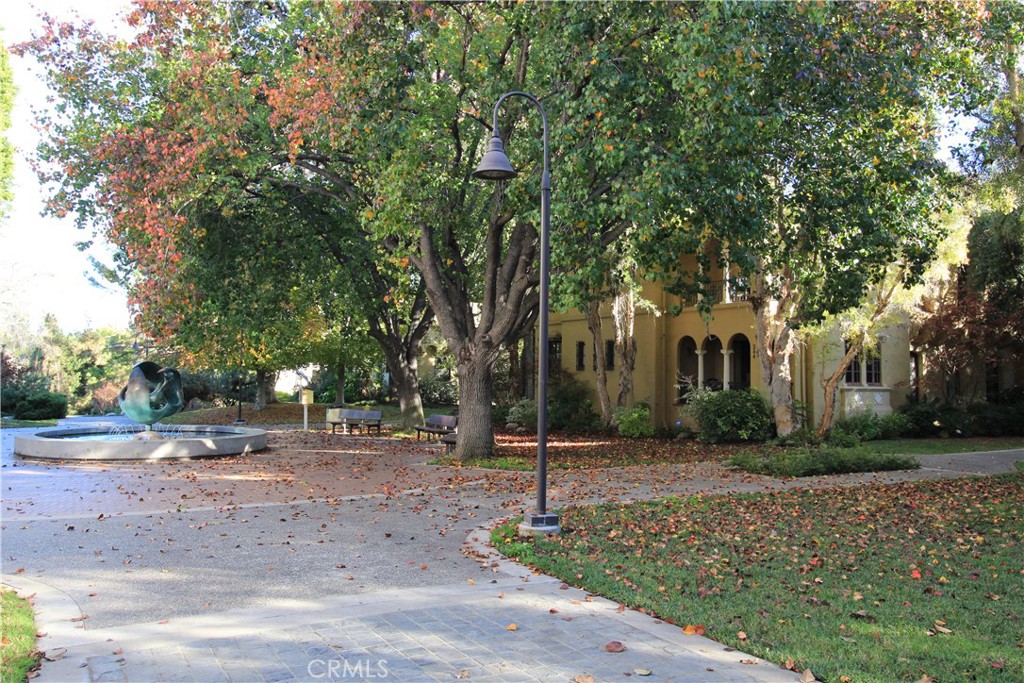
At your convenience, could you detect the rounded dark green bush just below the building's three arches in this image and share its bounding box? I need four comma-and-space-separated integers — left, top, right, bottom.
687, 389, 775, 443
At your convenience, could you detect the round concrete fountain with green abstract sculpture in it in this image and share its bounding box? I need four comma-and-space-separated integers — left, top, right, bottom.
14, 360, 266, 461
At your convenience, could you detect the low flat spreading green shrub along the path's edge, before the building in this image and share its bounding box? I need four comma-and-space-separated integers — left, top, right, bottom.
726, 446, 921, 477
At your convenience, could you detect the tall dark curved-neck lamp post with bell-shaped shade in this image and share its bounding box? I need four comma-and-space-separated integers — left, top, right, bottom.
473, 90, 561, 533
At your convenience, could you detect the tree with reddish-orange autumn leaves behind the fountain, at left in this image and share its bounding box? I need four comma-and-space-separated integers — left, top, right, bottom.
19, 2, 432, 423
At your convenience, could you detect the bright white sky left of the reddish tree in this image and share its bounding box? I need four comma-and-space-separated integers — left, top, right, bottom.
0, 0, 130, 332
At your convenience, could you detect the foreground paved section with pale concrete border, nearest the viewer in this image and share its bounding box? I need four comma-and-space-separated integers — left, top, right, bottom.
4, 548, 799, 683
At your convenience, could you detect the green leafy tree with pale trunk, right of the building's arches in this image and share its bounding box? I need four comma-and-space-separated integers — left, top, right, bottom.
641, 3, 979, 434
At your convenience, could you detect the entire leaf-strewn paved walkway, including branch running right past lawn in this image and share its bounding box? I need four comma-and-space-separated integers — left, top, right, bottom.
0, 430, 1024, 682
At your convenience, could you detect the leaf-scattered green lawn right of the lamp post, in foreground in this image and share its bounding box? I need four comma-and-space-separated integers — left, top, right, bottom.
494, 473, 1024, 683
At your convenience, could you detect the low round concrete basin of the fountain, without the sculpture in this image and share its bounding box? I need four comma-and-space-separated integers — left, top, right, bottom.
14, 425, 266, 462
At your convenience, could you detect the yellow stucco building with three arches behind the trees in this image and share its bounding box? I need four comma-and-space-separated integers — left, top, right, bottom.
549, 259, 920, 427
